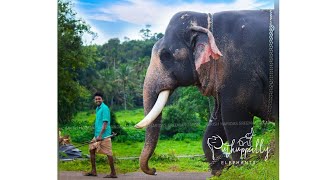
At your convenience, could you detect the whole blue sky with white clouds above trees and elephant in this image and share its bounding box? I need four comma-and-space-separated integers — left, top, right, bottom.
72, 0, 274, 44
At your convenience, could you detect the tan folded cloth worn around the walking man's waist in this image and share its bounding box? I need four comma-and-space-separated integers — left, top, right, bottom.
89, 138, 112, 156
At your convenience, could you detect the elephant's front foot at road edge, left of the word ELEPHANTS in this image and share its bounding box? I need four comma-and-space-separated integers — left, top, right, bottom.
210, 154, 230, 176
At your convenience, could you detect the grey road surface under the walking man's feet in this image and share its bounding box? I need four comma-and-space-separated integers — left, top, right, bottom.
58, 171, 211, 180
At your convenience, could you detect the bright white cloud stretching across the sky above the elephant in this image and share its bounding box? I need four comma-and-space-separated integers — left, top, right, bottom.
77, 0, 273, 42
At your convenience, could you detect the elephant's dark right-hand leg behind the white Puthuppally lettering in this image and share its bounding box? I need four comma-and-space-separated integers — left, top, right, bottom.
221, 102, 253, 165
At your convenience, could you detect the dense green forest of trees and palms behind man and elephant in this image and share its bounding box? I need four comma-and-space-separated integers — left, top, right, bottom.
58, 0, 212, 124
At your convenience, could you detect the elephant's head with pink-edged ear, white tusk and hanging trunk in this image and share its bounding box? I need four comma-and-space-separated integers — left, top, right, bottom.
135, 12, 222, 175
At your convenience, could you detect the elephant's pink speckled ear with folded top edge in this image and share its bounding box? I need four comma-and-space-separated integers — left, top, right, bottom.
191, 26, 222, 71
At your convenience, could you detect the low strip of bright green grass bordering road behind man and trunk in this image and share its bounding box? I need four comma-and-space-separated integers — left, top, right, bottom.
59, 140, 208, 173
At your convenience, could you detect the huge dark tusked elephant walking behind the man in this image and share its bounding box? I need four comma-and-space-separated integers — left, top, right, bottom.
135, 10, 279, 175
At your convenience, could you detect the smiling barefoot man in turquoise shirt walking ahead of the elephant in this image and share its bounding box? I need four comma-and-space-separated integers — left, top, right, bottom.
84, 92, 117, 178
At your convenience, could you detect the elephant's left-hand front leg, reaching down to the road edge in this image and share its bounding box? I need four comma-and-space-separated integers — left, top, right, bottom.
202, 97, 229, 175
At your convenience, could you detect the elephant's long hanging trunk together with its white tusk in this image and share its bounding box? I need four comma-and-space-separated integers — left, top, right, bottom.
135, 40, 176, 175
